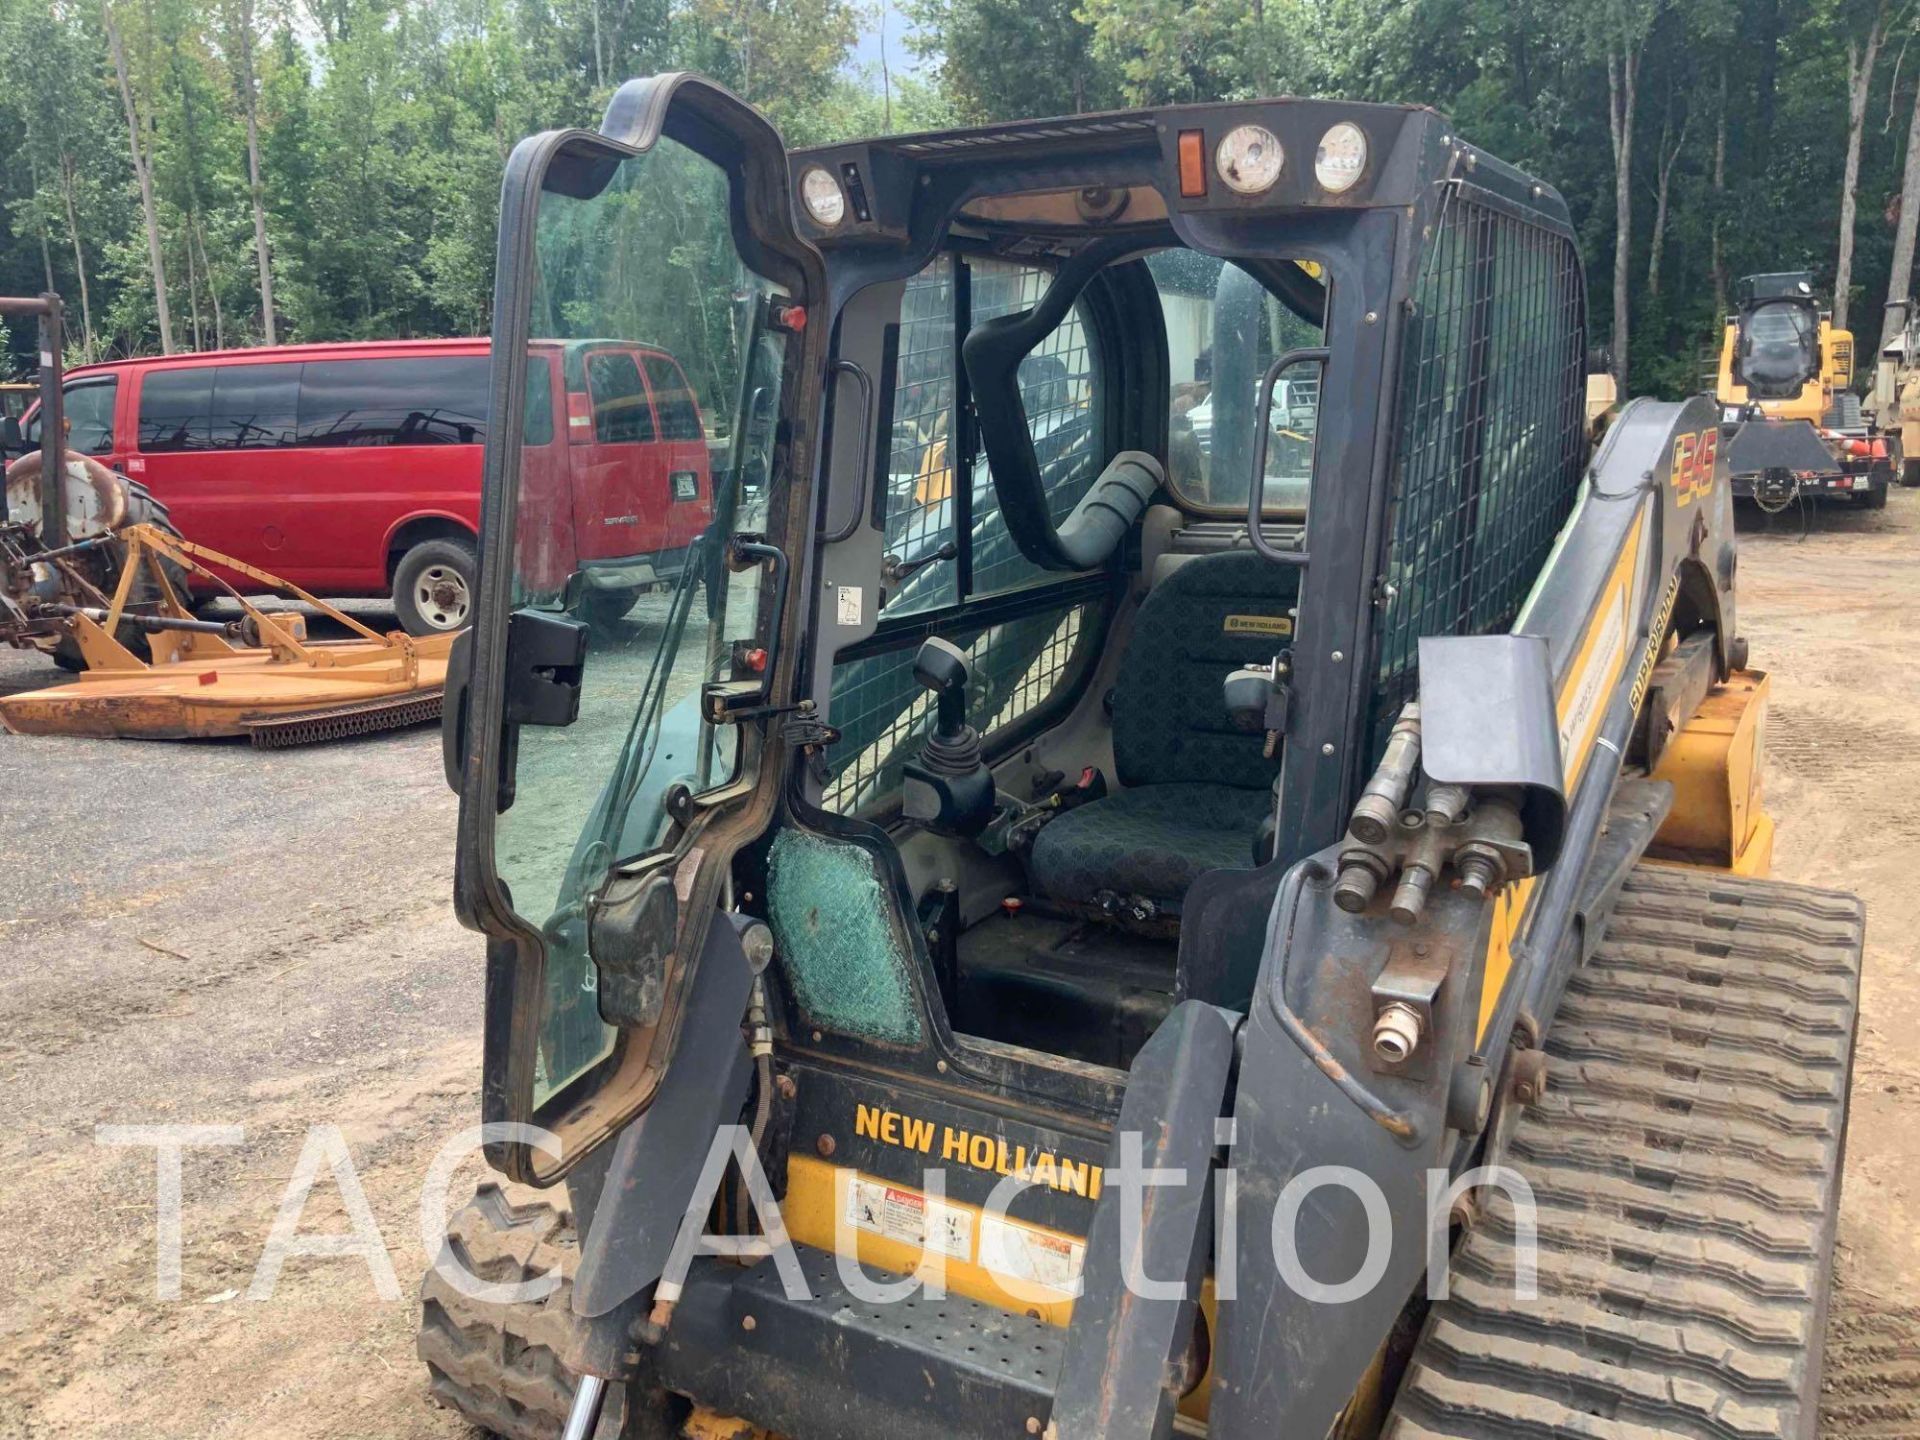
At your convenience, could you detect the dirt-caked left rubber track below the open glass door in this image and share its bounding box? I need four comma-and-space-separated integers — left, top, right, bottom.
419, 1181, 624, 1440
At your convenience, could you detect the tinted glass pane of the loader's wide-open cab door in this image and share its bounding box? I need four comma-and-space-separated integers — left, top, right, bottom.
493, 136, 785, 1108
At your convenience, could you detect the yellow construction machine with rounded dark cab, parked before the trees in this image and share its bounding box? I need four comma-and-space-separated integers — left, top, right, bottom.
1715, 271, 1897, 511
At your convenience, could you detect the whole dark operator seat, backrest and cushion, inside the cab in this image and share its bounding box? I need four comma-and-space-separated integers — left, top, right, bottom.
1029, 551, 1300, 914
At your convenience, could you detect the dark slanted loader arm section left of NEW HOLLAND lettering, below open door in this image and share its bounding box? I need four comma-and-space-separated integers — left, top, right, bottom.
574, 916, 753, 1317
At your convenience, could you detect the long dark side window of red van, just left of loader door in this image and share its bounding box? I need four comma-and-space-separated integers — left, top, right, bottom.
298, 355, 488, 445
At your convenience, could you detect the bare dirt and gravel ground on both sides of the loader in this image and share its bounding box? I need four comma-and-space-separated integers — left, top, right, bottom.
0, 492, 1920, 1440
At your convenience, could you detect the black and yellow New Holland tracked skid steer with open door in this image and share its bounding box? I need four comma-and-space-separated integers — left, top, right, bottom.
419, 75, 1862, 1440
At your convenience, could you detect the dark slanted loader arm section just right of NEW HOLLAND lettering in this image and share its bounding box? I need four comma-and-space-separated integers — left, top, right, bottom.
1048, 1000, 1233, 1440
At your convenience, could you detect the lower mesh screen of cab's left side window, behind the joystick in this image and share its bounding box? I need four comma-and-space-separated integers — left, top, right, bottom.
820, 605, 1087, 814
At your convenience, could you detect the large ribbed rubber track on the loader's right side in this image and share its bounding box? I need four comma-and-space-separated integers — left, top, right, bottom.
1382, 866, 1864, 1440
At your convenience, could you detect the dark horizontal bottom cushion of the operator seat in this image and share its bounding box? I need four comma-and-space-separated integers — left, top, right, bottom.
1029, 785, 1273, 914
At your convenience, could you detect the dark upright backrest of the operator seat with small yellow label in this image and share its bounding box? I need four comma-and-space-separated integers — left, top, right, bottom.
1114, 551, 1300, 789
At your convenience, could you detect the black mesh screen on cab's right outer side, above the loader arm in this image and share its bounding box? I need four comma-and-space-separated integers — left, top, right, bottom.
1375, 188, 1586, 733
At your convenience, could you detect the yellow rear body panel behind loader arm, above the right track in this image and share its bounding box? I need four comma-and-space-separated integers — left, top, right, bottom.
1649, 670, 1774, 876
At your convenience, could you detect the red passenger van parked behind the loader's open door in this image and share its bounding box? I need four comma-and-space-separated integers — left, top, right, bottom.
27, 338, 712, 636
